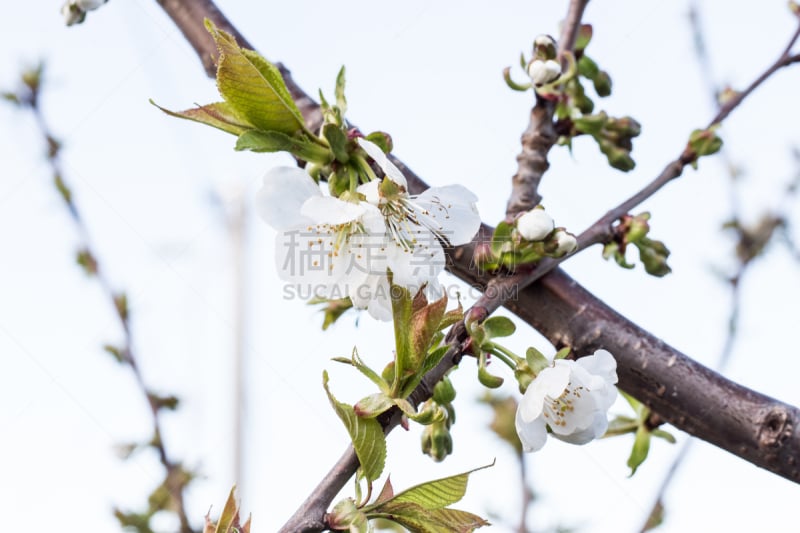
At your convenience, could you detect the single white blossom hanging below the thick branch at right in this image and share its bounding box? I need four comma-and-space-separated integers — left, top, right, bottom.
516, 350, 617, 452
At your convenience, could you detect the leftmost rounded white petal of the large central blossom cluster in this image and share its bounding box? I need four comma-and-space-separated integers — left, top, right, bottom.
256, 167, 322, 230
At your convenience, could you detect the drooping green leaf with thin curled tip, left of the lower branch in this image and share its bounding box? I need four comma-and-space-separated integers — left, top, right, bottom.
322, 372, 386, 482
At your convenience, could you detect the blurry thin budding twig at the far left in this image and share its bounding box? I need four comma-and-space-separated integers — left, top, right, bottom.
5, 67, 194, 533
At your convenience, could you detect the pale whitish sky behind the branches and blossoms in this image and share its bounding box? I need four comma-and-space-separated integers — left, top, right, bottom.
0, 0, 800, 533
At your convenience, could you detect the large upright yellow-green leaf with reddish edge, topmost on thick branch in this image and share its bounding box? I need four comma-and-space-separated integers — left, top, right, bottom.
206, 19, 310, 135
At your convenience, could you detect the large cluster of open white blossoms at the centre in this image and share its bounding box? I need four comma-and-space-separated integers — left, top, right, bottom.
257, 139, 480, 320
